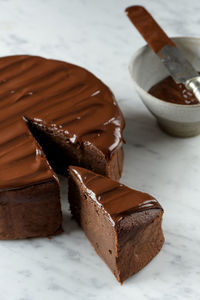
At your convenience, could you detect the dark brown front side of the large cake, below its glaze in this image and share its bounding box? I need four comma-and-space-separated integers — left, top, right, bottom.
0, 179, 62, 240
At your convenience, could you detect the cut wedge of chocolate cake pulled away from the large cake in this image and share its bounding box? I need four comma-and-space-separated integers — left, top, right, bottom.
69, 166, 164, 283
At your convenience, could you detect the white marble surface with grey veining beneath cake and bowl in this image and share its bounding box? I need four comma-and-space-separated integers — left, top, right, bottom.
0, 0, 200, 300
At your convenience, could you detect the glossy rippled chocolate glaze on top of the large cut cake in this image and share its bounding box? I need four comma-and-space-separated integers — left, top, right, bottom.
0, 56, 124, 190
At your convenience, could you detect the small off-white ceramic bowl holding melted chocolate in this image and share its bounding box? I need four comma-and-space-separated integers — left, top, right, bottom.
129, 37, 200, 137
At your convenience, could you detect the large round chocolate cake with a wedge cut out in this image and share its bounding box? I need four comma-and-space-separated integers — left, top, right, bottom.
0, 56, 124, 239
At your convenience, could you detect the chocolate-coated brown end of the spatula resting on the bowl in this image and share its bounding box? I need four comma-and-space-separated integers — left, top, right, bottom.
126, 5, 176, 53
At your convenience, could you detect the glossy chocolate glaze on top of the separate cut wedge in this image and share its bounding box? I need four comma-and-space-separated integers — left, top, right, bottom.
70, 166, 161, 225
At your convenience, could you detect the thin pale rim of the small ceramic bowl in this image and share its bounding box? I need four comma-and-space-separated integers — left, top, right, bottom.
128, 36, 200, 109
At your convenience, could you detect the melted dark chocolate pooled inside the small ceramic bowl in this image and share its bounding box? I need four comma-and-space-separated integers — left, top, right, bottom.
149, 76, 199, 105
